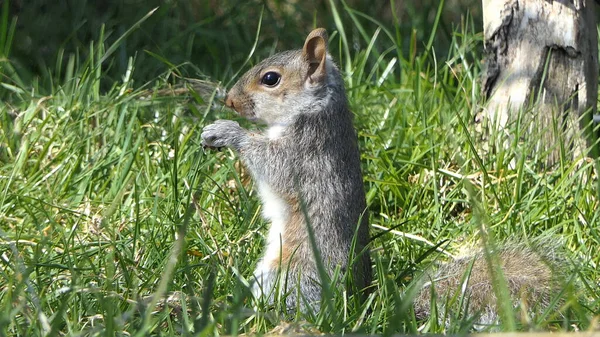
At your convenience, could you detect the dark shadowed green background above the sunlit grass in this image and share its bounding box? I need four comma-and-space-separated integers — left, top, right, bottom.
5, 0, 481, 85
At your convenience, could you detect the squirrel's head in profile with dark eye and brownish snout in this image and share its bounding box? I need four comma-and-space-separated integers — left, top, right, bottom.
226, 28, 343, 126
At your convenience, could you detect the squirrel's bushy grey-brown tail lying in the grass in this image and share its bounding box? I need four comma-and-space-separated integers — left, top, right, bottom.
414, 242, 568, 330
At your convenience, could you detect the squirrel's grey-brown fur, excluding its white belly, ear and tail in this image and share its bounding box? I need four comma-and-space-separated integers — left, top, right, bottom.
202, 28, 371, 310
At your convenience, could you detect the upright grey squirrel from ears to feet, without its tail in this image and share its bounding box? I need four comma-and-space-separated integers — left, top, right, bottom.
201, 28, 372, 312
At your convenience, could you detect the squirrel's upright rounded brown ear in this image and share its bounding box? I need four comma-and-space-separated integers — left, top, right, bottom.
302, 28, 328, 83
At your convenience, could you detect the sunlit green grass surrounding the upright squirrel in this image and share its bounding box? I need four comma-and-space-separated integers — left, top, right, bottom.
0, 1, 600, 336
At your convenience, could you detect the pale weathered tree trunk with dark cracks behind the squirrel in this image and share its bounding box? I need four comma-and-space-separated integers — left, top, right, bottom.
482, 0, 598, 165
